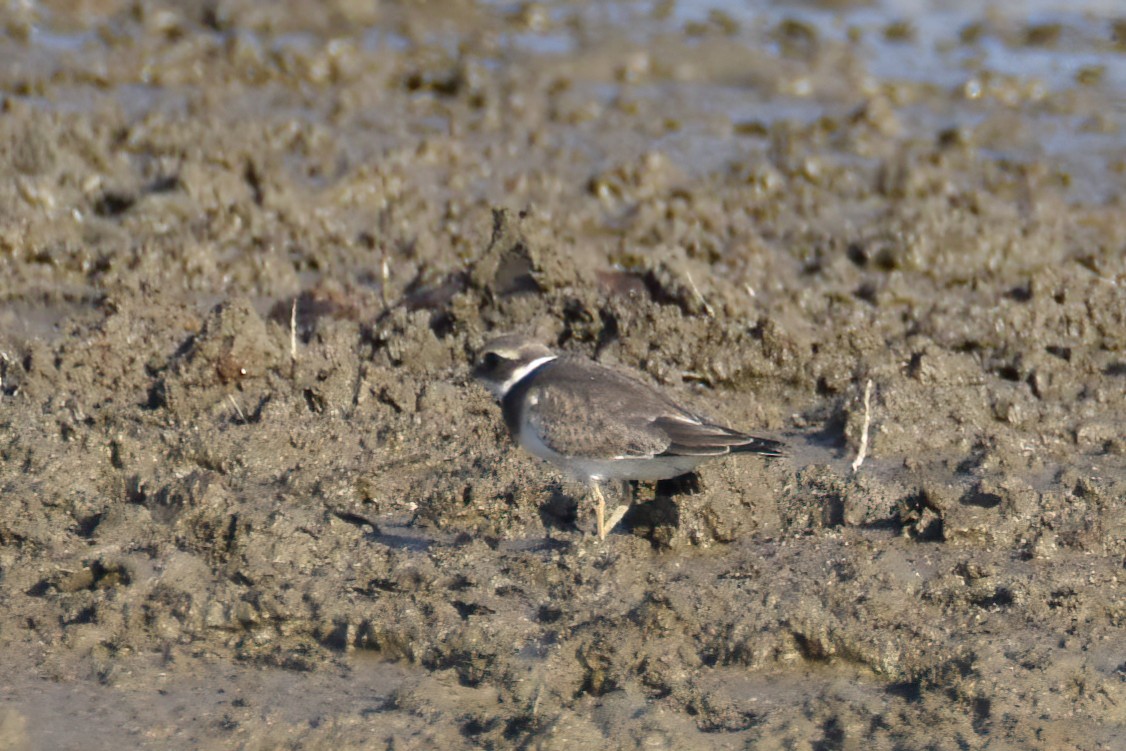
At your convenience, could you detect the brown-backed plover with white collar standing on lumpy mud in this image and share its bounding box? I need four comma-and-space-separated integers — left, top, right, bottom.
473, 334, 784, 539
